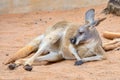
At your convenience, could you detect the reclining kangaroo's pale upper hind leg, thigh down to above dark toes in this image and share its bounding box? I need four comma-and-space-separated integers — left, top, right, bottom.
24, 31, 62, 70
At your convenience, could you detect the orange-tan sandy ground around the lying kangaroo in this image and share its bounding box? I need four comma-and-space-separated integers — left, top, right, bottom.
0, 5, 120, 80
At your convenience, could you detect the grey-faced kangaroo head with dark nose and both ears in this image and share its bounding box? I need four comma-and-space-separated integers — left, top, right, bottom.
70, 9, 105, 45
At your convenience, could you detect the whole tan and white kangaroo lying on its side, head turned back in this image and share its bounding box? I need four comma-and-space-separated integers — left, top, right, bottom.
5, 9, 105, 71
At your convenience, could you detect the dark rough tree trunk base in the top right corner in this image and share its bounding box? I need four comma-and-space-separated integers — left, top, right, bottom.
103, 0, 120, 16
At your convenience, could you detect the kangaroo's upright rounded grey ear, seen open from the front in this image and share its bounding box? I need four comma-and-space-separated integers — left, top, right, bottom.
85, 9, 95, 24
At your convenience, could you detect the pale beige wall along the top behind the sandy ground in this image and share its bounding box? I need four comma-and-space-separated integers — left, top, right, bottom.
0, 0, 108, 14
